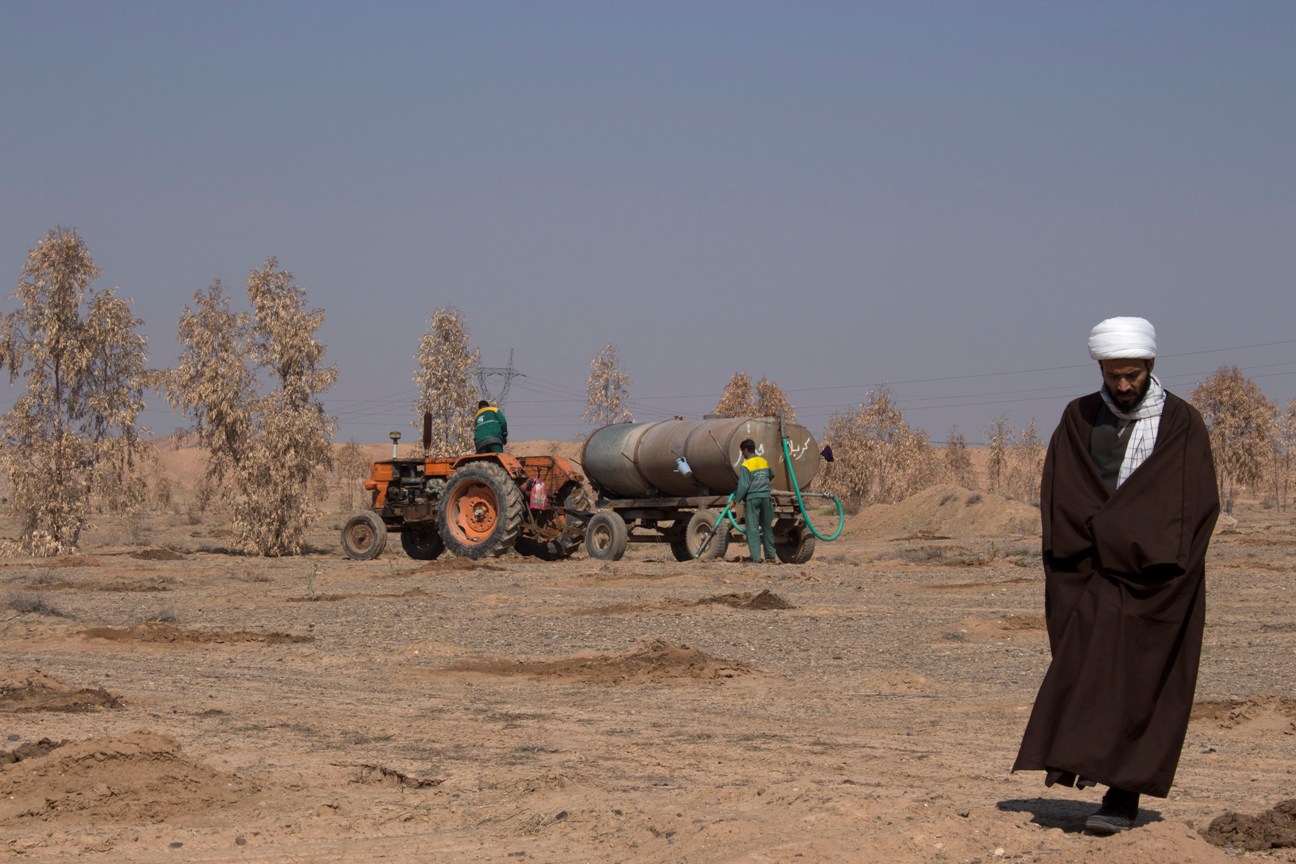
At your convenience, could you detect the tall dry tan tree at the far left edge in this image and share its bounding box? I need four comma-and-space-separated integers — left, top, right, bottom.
0, 228, 150, 556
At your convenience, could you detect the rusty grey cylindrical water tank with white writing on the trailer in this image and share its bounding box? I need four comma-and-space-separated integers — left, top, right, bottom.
581, 417, 819, 499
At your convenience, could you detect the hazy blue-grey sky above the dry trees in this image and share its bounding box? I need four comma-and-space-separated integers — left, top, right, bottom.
0, 0, 1296, 440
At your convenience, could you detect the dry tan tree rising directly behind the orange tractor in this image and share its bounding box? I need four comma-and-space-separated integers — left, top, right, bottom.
413, 306, 480, 456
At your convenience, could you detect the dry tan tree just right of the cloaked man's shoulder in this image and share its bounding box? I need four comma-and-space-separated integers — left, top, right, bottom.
1191, 367, 1275, 513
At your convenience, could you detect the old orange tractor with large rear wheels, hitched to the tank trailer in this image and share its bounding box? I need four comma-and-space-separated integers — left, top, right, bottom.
342, 417, 590, 561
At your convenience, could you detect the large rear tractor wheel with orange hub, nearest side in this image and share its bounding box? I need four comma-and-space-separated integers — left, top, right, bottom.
437, 462, 526, 558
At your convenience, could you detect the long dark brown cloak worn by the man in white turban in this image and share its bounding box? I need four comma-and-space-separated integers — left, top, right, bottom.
1012, 392, 1220, 798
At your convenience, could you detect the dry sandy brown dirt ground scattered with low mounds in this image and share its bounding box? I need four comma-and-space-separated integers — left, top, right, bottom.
0, 463, 1296, 864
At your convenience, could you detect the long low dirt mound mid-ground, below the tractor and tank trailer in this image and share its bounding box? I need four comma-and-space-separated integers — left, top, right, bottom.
448, 639, 753, 684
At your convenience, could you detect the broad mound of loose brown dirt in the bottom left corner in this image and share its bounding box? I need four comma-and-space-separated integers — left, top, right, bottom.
0, 729, 241, 825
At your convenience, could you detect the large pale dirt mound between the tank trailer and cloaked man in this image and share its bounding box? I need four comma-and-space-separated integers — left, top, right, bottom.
846, 486, 1039, 540
